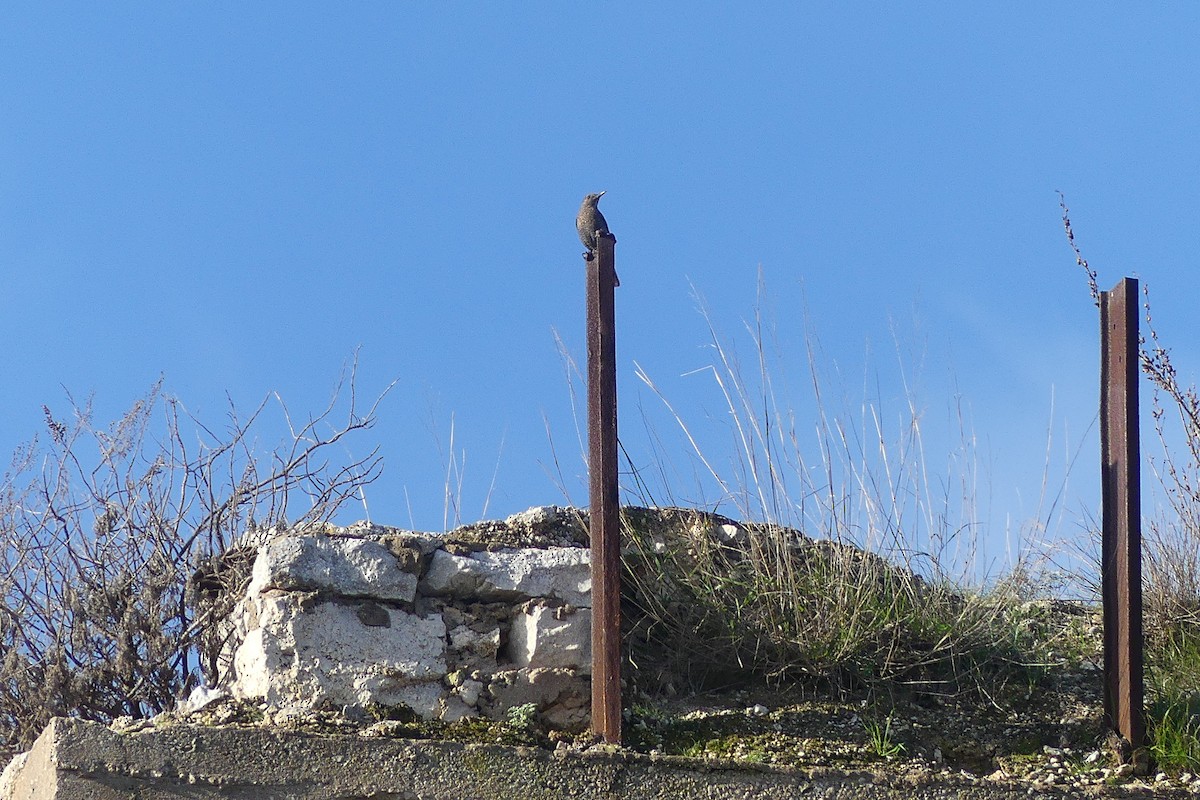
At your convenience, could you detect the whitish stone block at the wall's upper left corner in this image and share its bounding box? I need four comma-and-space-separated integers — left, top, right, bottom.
247, 536, 418, 602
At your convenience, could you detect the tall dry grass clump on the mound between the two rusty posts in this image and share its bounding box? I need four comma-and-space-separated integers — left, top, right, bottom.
625, 277, 1080, 702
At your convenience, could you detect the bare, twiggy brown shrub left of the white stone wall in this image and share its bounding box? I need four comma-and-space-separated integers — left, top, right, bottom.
0, 359, 386, 744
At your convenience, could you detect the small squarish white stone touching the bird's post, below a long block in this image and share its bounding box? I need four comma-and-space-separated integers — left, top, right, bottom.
509, 606, 592, 674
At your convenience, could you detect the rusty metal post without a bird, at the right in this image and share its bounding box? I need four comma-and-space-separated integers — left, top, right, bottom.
1100, 278, 1146, 751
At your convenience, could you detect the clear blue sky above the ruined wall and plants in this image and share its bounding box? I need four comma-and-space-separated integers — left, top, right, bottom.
0, 2, 1200, 573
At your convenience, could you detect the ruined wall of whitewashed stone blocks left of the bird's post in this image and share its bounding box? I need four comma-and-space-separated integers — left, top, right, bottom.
223, 507, 592, 729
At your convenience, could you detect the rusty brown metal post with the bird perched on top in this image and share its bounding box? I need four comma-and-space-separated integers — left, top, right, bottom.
587, 234, 620, 744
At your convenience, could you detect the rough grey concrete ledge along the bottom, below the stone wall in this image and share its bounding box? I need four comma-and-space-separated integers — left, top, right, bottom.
0, 718, 1156, 800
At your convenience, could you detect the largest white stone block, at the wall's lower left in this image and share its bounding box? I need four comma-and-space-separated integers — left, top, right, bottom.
230, 595, 446, 717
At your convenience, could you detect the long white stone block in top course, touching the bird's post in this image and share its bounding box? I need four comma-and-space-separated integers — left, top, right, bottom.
421, 547, 592, 606
